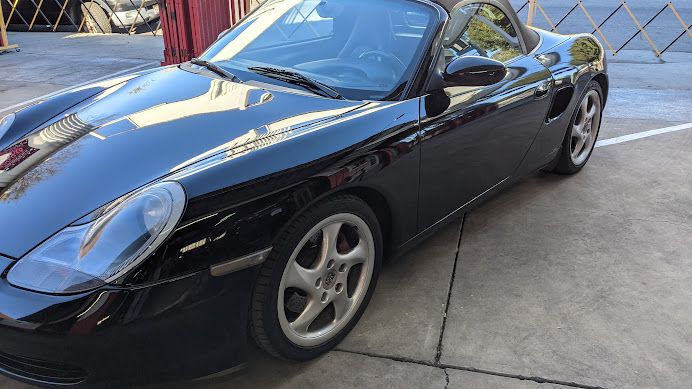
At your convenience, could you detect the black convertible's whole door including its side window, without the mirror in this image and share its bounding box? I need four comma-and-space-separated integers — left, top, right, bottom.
419, 3, 552, 230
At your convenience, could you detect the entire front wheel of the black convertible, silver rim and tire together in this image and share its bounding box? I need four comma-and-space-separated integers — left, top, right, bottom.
251, 195, 382, 360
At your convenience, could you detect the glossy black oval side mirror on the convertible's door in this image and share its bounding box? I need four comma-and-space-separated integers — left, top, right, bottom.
443, 56, 507, 86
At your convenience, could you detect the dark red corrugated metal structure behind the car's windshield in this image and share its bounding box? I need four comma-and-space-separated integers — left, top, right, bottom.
159, 0, 247, 65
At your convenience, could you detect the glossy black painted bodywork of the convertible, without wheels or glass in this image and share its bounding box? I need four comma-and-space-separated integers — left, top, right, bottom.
0, 0, 607, 384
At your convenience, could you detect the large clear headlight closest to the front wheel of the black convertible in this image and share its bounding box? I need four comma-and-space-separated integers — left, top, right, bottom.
7, 182, 185, 294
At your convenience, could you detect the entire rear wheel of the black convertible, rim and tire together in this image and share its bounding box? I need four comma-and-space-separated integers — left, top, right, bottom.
552, 81, 603, 174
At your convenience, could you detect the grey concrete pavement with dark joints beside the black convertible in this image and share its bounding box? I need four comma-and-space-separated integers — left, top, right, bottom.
0, 31, 692, 388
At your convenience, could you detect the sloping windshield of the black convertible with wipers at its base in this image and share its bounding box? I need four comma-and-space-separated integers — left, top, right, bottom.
201, 0, 437, 100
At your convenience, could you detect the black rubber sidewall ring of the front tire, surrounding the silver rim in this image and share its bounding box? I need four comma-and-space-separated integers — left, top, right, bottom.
253, 196, 383, 361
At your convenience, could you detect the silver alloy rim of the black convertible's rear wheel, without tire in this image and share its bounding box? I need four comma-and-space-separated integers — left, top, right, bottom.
570, 89, 601, 166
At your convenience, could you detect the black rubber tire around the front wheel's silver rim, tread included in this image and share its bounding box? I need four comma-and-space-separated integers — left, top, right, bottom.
250, 195, 383, 361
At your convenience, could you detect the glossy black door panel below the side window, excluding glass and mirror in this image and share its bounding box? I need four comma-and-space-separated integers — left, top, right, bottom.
419, 51, 551, 229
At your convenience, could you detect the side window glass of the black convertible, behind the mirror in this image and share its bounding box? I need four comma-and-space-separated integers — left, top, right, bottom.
443, 4, 522, 64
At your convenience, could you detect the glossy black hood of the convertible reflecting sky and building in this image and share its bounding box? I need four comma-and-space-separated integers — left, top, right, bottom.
0, 67, 362, 258
